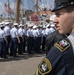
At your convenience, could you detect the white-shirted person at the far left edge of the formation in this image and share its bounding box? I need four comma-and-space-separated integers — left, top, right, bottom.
0, 24, 8, 58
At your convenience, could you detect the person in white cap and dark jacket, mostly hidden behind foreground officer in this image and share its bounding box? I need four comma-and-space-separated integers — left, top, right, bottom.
44, 14, 67, 54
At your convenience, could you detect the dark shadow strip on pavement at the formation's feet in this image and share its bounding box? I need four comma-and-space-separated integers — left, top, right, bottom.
0, 53, 45, 62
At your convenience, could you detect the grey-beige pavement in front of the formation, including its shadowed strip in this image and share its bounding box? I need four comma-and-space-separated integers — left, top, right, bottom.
0, 54, 45, 75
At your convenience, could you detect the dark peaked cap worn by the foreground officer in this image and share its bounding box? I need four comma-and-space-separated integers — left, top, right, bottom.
51, 0, 74, 12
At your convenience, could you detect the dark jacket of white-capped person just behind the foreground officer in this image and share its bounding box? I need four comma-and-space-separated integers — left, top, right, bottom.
44, 30, 67, 54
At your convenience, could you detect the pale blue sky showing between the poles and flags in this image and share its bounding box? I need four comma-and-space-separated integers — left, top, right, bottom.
0, 0, 54, 17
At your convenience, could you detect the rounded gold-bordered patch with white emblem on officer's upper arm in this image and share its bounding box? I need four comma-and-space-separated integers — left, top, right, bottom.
38, 58, 52, 75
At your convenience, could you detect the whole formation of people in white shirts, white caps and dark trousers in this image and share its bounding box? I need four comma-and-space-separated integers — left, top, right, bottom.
0, 19, 55, 58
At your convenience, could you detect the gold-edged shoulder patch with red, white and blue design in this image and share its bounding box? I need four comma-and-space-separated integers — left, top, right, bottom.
54, 40, 70, 52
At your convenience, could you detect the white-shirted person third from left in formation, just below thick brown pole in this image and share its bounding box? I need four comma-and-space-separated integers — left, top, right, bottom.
10, 23, 20, 57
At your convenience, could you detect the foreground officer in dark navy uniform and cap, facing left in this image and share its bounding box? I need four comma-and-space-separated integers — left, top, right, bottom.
35, 0, 74, 75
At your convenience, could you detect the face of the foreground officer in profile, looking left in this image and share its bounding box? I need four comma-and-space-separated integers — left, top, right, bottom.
54, 8, 74, 34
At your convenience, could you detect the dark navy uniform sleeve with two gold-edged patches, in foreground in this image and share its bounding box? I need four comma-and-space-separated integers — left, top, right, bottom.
35, 40, 74, 75
